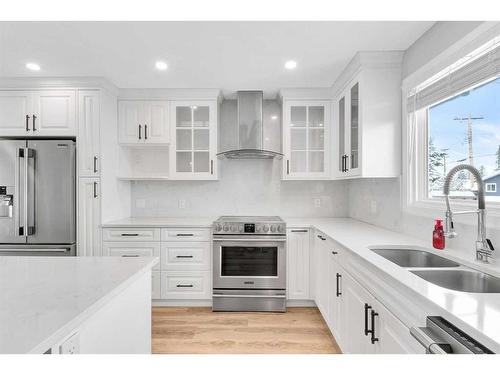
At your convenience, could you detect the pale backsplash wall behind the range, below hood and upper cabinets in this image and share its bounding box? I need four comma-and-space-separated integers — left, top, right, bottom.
131, 159, 348, 217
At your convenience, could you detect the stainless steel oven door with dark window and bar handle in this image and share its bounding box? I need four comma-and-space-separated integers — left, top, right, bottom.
213, 236, 286, 289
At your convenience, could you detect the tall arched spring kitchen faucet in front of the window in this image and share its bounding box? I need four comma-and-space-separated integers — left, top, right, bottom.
443, 164, 495, 263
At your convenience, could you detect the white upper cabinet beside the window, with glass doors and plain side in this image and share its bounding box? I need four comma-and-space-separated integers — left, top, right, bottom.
333, 52, 402, 178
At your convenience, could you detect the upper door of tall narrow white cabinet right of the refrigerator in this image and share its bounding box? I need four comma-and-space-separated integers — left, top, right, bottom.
78, 90, 101, 177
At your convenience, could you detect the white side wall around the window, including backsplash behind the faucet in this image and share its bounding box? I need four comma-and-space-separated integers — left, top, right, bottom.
348, 22, 500, 259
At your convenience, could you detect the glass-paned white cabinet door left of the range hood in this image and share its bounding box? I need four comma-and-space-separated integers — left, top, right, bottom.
170, 101, 217, 180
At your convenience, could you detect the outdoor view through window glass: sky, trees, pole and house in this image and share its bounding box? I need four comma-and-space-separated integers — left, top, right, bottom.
428, 78, 500, 202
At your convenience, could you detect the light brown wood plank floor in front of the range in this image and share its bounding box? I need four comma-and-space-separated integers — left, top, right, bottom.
152, 307, 340, 354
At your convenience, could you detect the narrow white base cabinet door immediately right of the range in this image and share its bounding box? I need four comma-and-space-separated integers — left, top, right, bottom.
286, 228, 311, 300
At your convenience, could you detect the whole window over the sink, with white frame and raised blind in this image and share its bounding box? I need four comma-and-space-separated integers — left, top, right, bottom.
403, 36, 500, 212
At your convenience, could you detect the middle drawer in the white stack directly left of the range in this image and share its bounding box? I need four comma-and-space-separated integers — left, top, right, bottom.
161, 242, 211, 271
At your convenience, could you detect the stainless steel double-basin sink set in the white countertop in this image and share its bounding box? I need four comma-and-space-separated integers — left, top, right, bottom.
371, 248, 500, 293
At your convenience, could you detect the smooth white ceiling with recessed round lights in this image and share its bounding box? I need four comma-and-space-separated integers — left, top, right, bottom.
0, 21, 433, 94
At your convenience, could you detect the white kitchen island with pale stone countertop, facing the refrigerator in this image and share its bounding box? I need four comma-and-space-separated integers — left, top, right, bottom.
0, 257, 158, 354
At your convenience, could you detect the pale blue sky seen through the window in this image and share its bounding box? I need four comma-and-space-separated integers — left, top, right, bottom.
429, 78, 500, 180
